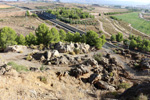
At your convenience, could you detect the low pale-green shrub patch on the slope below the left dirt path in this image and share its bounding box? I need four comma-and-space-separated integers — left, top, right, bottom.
8, 62, 28, 72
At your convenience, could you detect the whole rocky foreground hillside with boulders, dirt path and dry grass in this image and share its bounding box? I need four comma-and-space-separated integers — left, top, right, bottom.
0, 42, 150, 100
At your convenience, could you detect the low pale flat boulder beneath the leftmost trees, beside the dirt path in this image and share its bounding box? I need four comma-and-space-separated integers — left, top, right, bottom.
4, 45, 27, 52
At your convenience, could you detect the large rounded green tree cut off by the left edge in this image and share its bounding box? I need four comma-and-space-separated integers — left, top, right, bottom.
0, 27, 17, 49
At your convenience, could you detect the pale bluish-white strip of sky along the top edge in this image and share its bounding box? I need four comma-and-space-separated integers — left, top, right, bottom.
60, 0, 150, 5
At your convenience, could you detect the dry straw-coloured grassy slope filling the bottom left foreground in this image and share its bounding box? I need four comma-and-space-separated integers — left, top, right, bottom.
0, 70, 97, 100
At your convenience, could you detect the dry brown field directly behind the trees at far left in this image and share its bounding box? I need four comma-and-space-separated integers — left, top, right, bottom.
0, 16, 52, 35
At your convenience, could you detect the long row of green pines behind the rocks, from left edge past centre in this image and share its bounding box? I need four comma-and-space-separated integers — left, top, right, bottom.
0, 24, 106, 50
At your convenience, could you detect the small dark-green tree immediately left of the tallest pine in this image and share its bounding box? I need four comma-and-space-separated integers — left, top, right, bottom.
25, 32, 37, 45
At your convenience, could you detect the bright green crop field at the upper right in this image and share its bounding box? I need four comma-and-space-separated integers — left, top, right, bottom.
115, 12, 150, 34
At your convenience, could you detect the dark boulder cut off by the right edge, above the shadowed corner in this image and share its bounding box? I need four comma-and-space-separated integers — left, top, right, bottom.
140, 58, 150, 69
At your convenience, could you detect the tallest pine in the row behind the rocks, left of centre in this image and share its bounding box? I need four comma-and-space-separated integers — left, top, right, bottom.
35, 24, 49, 45
